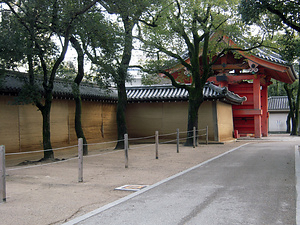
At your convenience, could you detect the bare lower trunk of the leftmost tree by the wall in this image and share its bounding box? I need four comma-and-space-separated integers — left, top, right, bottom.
41, 92, 54, 160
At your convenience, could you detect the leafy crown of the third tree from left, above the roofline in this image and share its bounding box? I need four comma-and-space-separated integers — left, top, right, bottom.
82, 0, 157, 85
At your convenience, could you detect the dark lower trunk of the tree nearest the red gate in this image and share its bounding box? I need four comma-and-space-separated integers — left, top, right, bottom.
184, 89, 203, 146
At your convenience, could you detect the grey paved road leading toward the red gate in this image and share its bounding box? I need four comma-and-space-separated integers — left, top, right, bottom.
68, 141, 299, 225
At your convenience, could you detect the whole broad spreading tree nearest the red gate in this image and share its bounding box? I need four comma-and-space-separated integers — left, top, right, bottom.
138, 0, 262, 146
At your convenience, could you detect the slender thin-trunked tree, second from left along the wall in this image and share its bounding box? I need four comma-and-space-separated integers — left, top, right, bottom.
66, 5, 116, 155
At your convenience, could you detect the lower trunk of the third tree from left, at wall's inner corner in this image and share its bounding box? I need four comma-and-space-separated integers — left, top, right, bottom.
115, 81, 127, 149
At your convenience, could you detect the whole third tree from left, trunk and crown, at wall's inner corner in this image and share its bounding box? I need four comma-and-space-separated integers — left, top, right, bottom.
84, 0, 154, 149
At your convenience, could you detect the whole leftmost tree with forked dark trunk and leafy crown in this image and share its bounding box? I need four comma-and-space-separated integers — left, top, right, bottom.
1, 0, 97, 159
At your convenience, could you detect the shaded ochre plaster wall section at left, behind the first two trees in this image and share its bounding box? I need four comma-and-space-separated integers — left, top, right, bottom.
0, 96, 117, 153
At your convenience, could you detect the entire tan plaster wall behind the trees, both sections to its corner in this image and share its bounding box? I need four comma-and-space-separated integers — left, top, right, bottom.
0, 96, 233, 153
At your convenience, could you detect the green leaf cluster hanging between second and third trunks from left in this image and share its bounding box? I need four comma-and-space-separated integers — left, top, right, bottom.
75, 7, 124, 86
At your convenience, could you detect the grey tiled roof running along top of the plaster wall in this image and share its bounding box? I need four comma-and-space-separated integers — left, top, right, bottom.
0, 73, 246, 105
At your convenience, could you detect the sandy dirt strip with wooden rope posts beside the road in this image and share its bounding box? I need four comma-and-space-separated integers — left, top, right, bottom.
0, 141, 245, 225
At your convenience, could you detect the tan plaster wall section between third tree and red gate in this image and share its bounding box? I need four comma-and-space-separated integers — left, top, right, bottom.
126, 101, 233, 141
